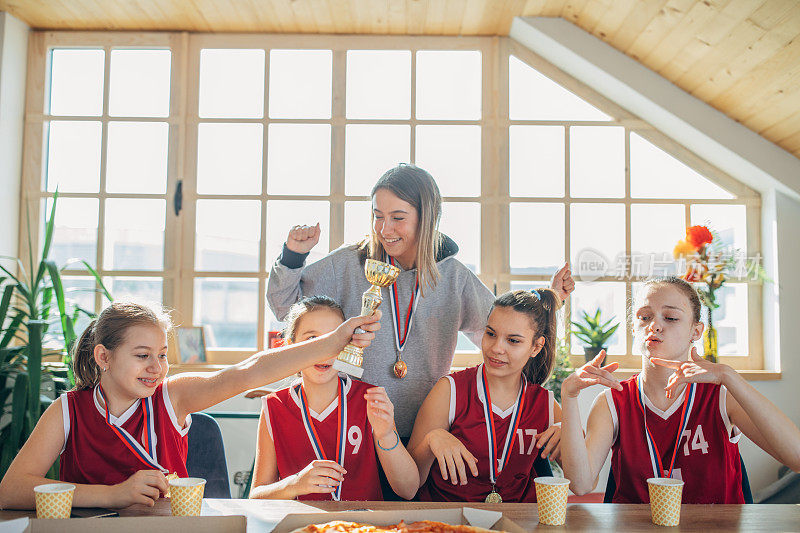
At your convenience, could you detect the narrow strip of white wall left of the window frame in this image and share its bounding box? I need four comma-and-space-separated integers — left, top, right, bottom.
0, 12, 29, 256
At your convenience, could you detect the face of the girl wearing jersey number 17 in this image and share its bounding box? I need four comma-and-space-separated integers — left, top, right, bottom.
481, 307, 544, 377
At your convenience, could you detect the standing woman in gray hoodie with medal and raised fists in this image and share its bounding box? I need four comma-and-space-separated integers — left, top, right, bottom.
267, 164, 575, 442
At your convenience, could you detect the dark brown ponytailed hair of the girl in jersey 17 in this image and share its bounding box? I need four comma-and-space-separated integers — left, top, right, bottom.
489, 289, 561, 385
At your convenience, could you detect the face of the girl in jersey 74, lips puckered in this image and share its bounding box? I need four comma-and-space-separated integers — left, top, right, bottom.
633, 283, 703, 360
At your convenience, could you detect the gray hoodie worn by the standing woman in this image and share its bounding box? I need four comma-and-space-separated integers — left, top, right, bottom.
267, 238, 494, 438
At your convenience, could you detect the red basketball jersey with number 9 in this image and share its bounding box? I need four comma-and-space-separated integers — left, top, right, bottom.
262, 376, 383, 500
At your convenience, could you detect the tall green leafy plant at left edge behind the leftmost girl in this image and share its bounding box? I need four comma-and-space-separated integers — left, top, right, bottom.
0, 193, 111, 477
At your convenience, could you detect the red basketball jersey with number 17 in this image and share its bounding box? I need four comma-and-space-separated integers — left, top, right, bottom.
419, 364, 554, 502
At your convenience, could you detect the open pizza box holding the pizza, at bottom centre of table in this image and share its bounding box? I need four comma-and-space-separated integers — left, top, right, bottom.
272, 507, 525, 533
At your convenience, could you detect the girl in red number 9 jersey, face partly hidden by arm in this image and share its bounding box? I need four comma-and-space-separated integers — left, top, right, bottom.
250, 296, 419, 500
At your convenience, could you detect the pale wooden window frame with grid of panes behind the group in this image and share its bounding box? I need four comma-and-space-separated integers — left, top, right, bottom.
19, 31, 764, 370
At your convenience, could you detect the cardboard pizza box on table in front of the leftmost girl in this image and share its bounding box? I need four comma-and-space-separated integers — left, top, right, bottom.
5, 516, 247, 533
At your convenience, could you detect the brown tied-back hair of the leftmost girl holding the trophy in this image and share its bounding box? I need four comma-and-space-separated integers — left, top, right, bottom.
72, 301, 172, 390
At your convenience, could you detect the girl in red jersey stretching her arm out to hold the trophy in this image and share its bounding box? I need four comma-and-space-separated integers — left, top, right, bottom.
0, 302, 380, 509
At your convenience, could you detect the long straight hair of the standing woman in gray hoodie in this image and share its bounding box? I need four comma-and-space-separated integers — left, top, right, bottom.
359, 163, 442, 296
